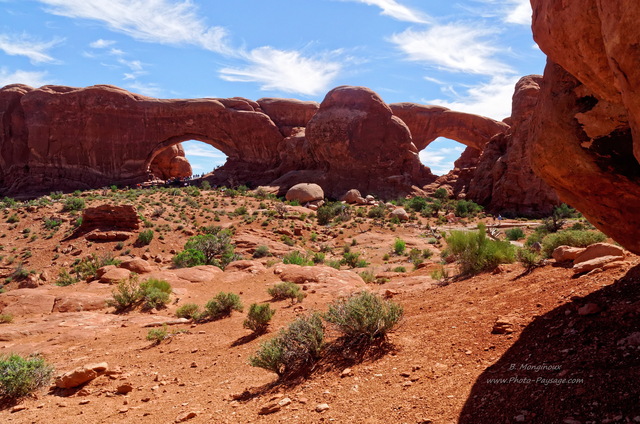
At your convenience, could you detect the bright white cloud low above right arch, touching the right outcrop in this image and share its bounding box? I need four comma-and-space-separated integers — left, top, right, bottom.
423, 76, 520, 121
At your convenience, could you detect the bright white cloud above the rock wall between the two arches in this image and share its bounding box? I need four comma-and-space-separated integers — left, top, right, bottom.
220, 46, 342, 96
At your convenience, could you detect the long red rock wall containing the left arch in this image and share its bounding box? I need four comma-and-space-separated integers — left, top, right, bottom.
0, 86, 283, 195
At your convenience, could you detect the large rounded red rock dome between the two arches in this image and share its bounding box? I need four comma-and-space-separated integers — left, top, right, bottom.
306, 86, 435, 198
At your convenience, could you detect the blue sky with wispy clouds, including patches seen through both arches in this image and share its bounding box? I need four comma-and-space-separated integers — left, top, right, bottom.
0, 0, 545, 174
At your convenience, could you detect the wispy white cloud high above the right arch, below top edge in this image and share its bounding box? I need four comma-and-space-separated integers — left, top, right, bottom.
390, 23, 513, 75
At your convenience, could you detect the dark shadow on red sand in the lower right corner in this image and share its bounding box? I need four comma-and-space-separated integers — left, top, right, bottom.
459, 265, 640, 424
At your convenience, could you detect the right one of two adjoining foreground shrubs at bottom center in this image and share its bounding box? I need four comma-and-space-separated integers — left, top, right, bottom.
325, 291, 403, 344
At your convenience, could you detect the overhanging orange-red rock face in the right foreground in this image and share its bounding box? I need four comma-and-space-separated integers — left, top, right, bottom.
530, 0, 640, 253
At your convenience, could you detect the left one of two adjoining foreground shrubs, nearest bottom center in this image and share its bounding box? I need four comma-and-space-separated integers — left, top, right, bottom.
249, 313, 324, 377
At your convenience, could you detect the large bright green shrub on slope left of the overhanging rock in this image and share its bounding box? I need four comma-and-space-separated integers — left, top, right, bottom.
446, 223, 515, 275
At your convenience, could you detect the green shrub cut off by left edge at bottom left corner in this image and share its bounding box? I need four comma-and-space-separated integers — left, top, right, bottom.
0, 354, 53, 400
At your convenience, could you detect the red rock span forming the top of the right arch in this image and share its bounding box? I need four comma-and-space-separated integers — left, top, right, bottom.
389, 103, 509, 150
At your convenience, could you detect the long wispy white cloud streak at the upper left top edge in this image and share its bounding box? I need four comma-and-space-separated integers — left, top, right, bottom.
38, 0, 227, 52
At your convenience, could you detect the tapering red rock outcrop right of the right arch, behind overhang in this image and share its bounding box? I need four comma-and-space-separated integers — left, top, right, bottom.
466, 75, 560, 217
